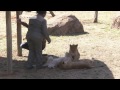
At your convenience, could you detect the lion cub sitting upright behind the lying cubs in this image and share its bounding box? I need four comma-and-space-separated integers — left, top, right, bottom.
69, 44, 80, 61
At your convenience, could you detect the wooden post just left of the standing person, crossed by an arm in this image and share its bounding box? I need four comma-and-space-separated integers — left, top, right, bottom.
16, 11, 22, 56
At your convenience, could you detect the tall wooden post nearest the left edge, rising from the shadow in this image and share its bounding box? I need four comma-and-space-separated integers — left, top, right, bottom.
6, 11, 12, 74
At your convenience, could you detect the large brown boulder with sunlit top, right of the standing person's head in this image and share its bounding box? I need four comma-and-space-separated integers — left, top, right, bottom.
48, 14, 84, 35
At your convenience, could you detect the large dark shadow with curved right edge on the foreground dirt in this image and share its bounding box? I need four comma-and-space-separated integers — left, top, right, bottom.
0, 57, 114, 79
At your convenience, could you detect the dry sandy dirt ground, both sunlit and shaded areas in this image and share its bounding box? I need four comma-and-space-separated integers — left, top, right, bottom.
0, 11, 120, 79
